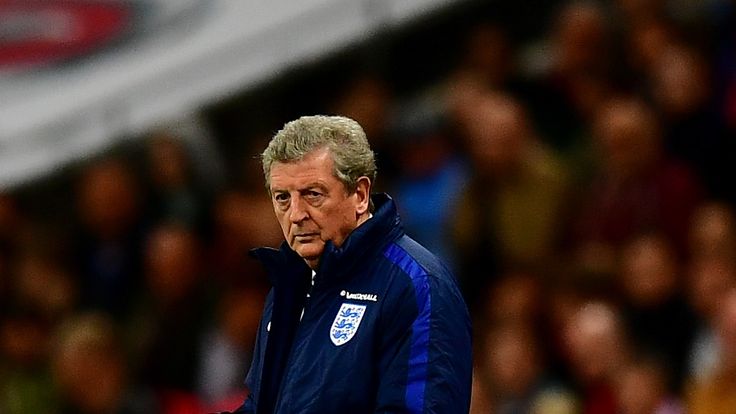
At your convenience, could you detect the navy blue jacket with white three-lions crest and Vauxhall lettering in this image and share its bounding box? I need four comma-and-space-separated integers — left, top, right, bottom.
236, 194, 472, 414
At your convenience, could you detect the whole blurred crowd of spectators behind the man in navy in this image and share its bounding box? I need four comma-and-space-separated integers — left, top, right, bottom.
0, 0, 736, 414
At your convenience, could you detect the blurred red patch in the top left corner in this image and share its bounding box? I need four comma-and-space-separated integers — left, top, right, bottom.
0, 0, 134, 70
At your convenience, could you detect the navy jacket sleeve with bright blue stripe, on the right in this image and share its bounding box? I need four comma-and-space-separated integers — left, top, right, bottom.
375, 273, 472, 414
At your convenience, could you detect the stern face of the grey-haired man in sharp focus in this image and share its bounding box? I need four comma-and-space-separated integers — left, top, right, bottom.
270, 148, 370, 268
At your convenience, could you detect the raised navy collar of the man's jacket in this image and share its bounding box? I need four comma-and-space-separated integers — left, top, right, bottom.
250, 193, 404, 286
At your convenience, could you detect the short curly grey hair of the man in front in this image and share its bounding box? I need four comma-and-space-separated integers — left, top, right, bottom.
261, 115, 376, 192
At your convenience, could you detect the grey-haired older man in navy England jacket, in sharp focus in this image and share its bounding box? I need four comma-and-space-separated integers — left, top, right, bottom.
224, 116, 472, 414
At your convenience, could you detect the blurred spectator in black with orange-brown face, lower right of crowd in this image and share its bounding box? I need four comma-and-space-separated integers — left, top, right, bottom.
619, 234, 696, 393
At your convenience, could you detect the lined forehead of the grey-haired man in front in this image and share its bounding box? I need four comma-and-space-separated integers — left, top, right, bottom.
269, 149, 339, 190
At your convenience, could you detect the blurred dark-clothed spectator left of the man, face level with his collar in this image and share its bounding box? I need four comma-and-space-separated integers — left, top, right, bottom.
126, 224, 212, 402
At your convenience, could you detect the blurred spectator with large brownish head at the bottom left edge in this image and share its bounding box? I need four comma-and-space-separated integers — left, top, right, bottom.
51, 313, 160, 414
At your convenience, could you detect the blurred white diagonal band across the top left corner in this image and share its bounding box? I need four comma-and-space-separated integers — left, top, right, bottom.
0, 0, 459, 190
